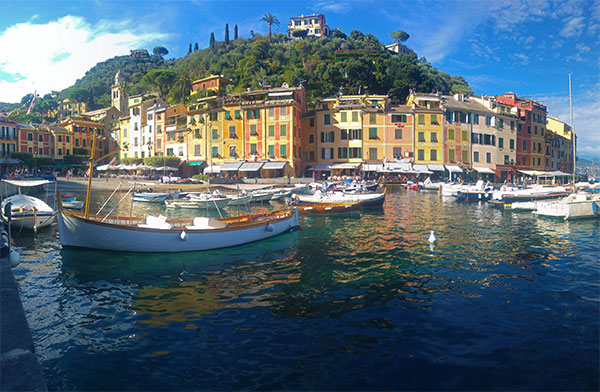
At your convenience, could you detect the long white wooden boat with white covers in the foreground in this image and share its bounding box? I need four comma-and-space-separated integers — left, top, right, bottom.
58, 209, 299, 253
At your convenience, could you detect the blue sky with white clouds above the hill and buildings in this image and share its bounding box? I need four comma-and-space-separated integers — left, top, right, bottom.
0, 0, 600, 161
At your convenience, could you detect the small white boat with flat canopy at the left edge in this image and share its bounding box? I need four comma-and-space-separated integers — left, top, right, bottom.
0, 180, 55, 230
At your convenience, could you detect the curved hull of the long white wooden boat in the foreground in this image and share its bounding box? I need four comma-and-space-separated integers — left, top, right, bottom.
58, 210, 299, 253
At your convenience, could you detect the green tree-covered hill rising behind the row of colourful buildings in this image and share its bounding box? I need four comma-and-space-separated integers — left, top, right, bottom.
5, 30, 472, 122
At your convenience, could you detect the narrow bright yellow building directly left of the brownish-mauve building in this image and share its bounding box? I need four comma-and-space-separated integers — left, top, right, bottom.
407, 93, 446, 164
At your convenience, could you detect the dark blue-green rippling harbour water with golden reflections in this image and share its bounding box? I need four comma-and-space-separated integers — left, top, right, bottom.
14, 189, 600, 390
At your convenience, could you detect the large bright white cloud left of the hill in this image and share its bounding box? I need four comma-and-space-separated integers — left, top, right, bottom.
0, 15, 166, 102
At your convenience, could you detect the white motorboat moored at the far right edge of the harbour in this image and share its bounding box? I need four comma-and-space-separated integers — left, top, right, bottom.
533, 193, 600, 220
